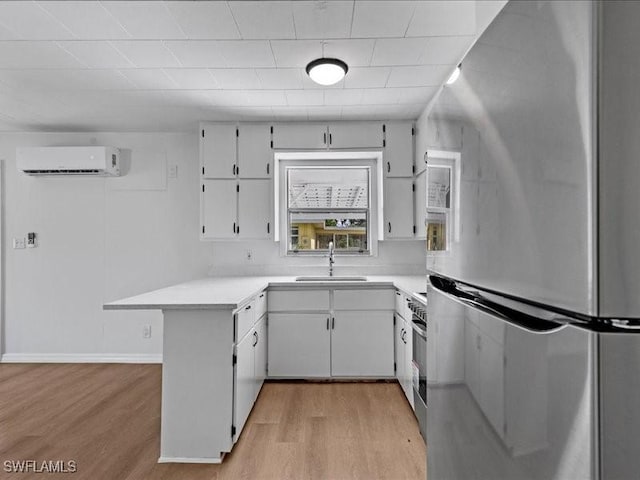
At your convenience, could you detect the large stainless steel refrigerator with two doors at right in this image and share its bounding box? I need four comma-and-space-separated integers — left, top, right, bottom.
426, 0, 640, 480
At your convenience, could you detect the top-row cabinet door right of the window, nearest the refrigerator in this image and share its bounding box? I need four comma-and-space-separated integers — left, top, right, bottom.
382, 122, 414, 177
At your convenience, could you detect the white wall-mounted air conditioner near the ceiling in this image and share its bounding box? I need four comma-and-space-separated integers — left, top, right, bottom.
16, 147, 120, 176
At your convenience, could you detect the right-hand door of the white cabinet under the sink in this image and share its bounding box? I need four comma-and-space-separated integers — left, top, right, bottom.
331, 311, 394, 377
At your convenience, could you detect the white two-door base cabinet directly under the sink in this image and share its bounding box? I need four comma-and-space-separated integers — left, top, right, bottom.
268, 288, 394, 378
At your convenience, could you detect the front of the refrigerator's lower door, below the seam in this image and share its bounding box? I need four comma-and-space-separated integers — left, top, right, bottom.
427, 277, 597, 480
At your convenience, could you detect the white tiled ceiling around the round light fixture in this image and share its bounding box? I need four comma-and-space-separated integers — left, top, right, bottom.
0, 0, 505, 131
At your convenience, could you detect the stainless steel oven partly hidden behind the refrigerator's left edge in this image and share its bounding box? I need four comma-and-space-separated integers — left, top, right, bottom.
409, 294, 427, 441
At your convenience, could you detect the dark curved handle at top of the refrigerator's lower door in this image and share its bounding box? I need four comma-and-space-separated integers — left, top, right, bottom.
429, 275, 567, 333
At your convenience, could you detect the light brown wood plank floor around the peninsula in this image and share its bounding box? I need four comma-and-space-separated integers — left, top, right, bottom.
0, 364, 426, 480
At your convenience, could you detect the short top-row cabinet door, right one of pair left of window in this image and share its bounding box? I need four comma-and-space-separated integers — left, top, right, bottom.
238, 123, 273, 178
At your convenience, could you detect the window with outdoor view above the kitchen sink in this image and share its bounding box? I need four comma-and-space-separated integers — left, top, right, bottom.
286, 166, 371, 254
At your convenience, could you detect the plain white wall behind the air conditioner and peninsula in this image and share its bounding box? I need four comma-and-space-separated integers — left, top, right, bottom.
0, 133, 213, 360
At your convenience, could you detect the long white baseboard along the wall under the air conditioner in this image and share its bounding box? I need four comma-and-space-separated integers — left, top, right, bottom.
0, 353, 162, 363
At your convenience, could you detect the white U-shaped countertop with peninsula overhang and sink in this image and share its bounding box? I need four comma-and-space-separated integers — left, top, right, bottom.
103, 275, 427, 310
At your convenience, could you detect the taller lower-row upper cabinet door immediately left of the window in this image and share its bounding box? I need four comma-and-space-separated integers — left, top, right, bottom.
237, 180, 273, 239
